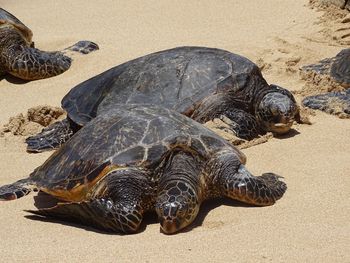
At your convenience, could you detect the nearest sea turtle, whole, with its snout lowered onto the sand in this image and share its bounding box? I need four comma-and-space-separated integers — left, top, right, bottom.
0, 104, 287, 234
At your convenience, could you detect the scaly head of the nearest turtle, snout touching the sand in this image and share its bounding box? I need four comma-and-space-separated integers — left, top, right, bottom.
156, 182, 199, 234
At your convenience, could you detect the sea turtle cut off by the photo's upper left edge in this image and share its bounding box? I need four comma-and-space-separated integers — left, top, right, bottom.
0, 8, 98, 80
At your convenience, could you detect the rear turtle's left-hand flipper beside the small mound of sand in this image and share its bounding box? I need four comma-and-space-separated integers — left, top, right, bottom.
26, 119, 80, 152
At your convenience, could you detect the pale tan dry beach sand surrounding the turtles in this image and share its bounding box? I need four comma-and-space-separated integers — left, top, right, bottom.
0, 0, 350, 262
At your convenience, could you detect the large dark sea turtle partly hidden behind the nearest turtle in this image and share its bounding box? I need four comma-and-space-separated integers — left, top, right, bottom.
27, 47, 298, 152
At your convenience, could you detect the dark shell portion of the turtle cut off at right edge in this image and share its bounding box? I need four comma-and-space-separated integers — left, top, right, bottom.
331, 48, 350, 87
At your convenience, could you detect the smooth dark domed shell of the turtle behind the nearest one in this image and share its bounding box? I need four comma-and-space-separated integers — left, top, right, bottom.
62, 47, 269, 126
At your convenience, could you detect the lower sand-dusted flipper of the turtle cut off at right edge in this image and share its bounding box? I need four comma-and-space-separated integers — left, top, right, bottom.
302, 89, 350, 118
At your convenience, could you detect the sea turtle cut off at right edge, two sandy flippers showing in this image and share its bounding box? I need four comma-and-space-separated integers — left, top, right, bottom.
302, 48, 350, 117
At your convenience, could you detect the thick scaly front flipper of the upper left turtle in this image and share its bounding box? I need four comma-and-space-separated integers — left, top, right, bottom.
1, 45, 72, 80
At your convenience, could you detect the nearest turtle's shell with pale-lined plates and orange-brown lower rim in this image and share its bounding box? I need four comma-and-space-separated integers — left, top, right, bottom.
31, 105, 246, 201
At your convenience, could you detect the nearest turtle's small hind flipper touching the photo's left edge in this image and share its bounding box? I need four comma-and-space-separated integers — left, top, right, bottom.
0, 178, 35, 201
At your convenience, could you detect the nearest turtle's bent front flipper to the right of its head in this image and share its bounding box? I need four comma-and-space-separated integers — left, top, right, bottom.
209, 152, 287, 206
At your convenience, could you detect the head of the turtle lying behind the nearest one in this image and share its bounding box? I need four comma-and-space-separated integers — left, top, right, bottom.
256, 85, 299, 134
